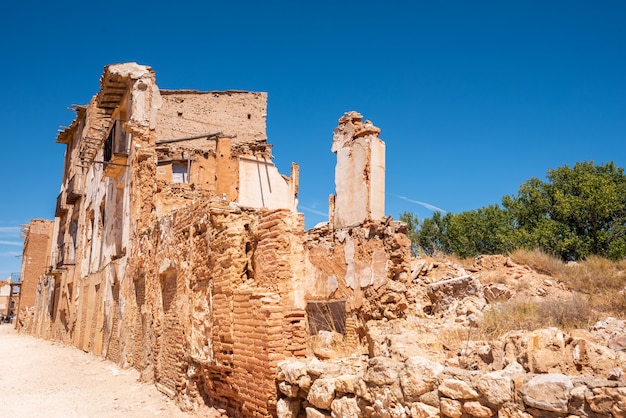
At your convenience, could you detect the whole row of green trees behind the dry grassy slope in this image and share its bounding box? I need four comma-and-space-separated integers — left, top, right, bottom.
401, 162, 626, 260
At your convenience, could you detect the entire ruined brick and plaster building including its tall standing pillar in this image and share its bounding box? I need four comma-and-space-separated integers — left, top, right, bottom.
20, 63, 410, 417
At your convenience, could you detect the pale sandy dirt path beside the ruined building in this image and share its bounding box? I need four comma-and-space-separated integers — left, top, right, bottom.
0, 324, 194, 418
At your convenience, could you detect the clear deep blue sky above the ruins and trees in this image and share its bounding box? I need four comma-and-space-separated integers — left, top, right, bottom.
0, 0, 626, 279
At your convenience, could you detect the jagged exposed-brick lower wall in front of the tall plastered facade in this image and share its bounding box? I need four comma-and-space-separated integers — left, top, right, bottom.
114, 202, 306, 416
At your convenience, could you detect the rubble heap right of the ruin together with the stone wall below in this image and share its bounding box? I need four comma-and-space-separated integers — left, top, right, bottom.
277, 256, 626, 418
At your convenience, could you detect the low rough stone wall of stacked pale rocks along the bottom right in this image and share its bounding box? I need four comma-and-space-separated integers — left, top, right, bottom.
277, 357, 626, 418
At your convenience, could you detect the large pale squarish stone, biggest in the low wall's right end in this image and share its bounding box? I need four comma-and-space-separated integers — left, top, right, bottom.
522, 374, 574, 413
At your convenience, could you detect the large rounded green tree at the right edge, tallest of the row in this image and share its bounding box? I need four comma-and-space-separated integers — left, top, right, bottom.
502, 162, 626, 260
